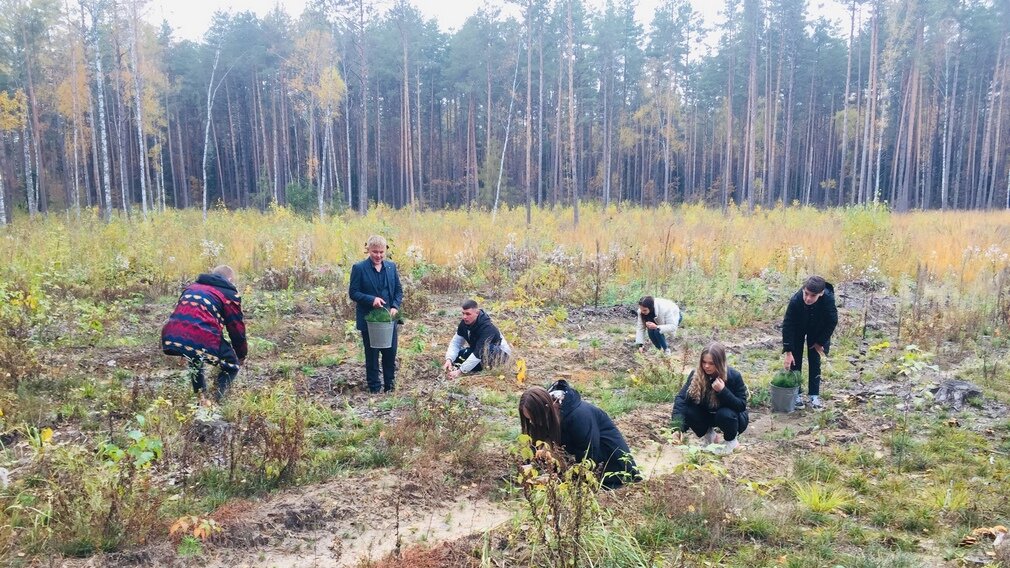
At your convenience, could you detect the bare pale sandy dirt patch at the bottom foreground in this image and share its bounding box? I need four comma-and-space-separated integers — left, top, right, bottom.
207, 474, 511, 568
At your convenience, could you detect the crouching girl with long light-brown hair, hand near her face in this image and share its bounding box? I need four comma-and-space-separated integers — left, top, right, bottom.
672, 342, 749, 454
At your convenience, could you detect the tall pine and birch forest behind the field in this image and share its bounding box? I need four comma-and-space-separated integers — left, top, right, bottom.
0, 0, 1010, 223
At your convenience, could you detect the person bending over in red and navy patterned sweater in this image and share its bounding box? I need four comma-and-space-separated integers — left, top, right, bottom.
162, 265, 248, 401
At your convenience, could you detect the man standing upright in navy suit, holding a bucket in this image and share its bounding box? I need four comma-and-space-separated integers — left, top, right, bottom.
347, 234, 403, 393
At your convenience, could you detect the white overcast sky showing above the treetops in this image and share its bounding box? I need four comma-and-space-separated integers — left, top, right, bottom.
146, 0, 846, 41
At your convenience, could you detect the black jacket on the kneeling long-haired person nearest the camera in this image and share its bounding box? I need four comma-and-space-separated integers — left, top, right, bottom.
549, 381, 641, 488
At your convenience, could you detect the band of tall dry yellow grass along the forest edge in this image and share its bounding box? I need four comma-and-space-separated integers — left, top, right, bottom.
0, 205, 1010, 285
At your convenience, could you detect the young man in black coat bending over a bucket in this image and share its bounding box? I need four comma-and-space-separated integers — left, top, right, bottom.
782, 276, 838, 408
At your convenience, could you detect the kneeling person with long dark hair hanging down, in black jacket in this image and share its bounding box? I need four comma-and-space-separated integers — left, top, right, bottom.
519, 381, 641, 489
